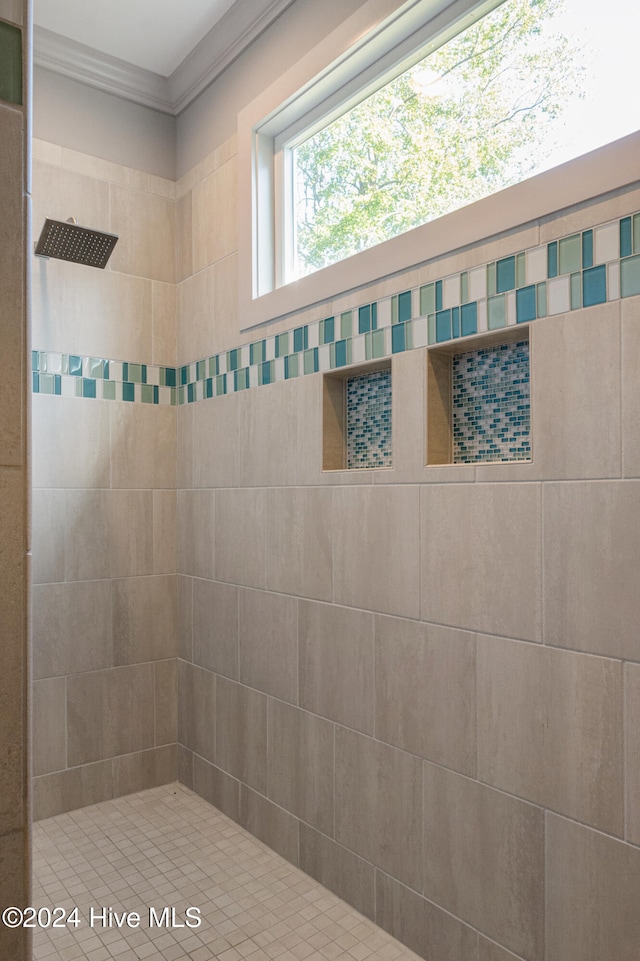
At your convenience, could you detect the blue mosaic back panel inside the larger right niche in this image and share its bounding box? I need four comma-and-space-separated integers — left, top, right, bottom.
452, 341, 531, 464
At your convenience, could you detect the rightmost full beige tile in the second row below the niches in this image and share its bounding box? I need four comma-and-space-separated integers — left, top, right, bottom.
478, 637, 623, 834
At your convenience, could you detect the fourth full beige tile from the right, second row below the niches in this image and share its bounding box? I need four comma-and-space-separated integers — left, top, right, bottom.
238, 590, 298, 704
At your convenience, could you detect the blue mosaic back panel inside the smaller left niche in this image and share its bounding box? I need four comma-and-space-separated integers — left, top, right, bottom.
346, 370, 391, 469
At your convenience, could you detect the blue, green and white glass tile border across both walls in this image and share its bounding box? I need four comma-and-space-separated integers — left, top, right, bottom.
33, 212, 640, 405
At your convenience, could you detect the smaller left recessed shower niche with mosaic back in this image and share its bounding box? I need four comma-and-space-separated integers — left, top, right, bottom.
322, 361, 393, 471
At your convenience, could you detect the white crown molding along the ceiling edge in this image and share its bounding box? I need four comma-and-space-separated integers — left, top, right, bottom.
33, 0, 295, 116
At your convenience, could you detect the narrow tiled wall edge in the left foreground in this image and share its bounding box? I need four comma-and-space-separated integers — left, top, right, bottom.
0, 0, 31, 961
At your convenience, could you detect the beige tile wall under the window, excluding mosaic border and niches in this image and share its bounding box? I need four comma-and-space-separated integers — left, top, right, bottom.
178, 133, 640, 961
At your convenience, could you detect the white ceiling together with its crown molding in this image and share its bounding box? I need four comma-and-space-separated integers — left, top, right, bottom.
33, 0, 294, 114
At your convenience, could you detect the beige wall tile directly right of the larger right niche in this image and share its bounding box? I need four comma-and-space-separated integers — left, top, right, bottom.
531, 302, 620, 479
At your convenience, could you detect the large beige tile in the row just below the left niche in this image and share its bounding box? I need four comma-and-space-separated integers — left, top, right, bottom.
333, 487, 420, 617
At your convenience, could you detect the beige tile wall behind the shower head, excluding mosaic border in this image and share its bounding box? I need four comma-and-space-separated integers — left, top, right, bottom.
32, 141, 179, 818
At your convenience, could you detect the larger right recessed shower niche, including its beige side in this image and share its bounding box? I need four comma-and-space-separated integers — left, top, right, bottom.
427, 327, 531, 466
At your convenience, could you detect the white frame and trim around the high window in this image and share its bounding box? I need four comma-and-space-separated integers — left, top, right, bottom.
238, 0, 640, 331
